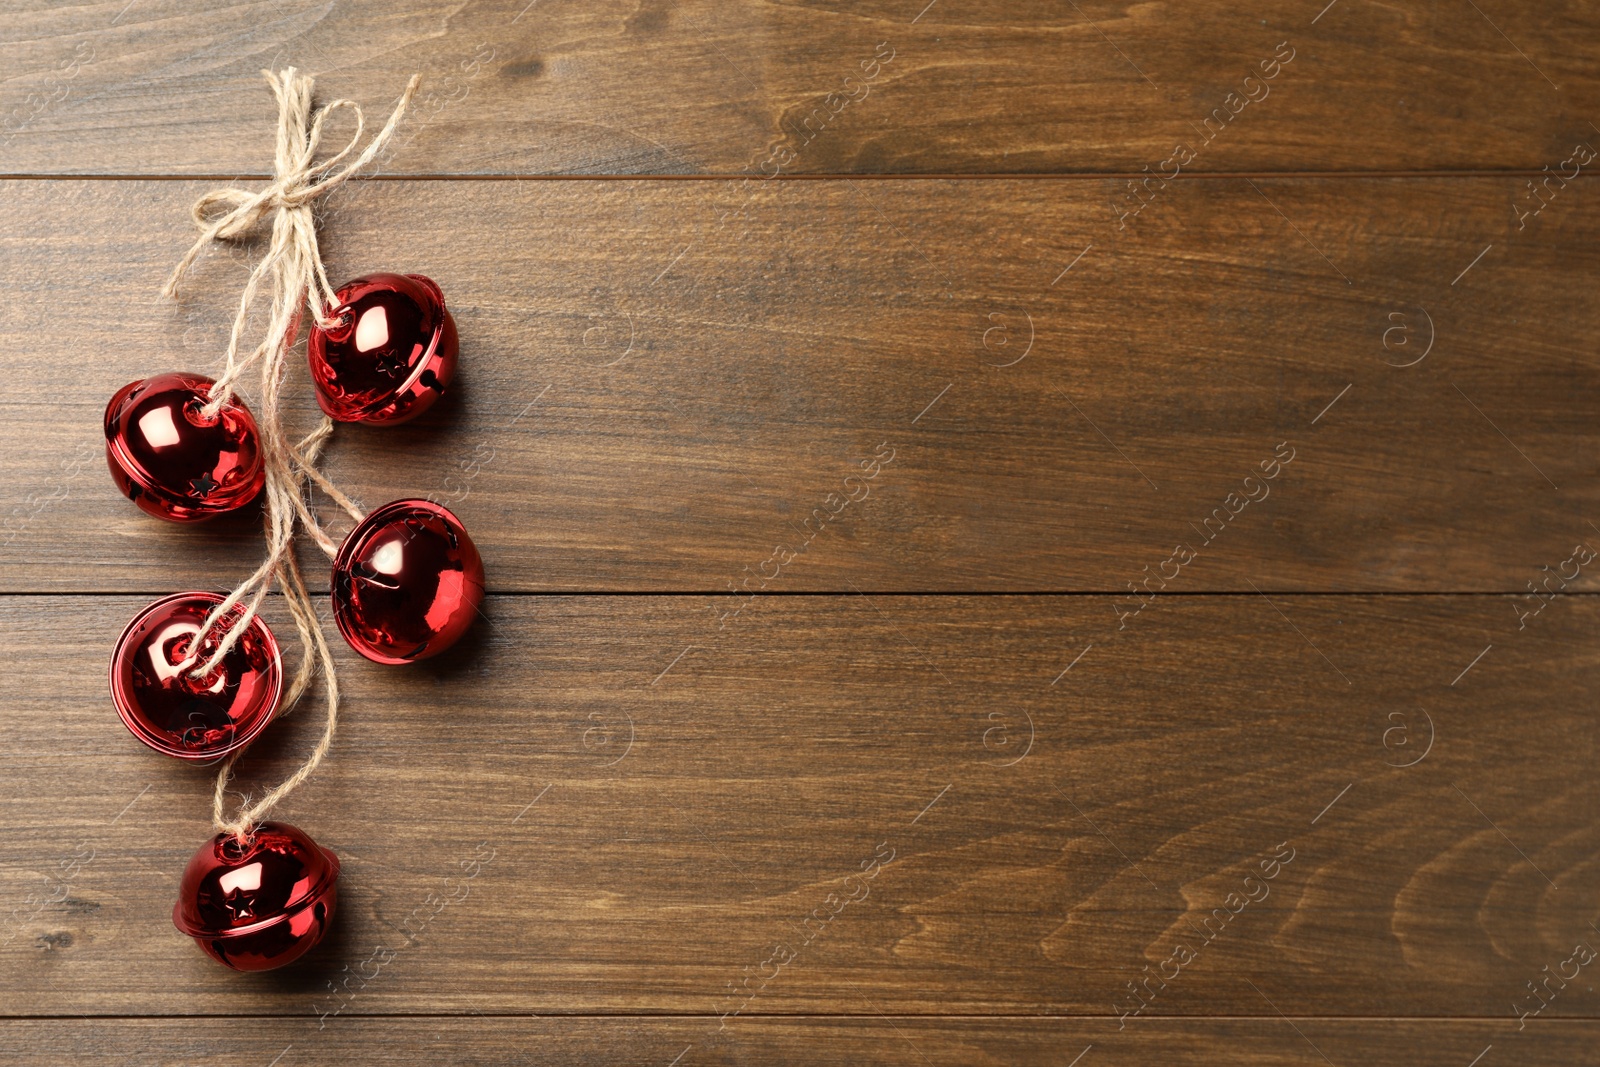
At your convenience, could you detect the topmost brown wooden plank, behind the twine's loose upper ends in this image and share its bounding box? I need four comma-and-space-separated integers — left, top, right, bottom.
0, 0, 1600, 174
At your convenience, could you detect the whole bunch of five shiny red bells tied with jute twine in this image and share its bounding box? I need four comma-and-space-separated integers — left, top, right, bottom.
120, 67, 464, 981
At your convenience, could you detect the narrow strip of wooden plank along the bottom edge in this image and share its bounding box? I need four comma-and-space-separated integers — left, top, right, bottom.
0, 1016, 1580, 1067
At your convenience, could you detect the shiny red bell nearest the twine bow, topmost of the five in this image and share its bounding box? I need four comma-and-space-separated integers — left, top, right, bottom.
306, 274, 459, 424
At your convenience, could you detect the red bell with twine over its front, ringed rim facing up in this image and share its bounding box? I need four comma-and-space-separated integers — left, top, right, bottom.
110, 592, 283, 760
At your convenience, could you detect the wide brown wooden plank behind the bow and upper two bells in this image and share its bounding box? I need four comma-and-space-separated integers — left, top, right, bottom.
0, 178, 1600, 591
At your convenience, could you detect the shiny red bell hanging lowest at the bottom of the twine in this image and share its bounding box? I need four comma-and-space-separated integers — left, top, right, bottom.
173, 822, 339, 971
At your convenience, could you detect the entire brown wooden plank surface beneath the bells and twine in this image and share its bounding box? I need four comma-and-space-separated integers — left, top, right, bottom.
0, 0, 1600, 1067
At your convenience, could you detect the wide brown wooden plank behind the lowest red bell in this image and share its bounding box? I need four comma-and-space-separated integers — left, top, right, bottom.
0, 595, 1600, 1017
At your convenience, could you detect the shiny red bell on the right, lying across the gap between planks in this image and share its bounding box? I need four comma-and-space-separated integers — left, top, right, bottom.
333, 501, 483, 664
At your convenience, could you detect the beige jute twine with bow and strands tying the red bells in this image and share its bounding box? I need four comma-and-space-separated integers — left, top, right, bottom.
162, 67, 421, 841
